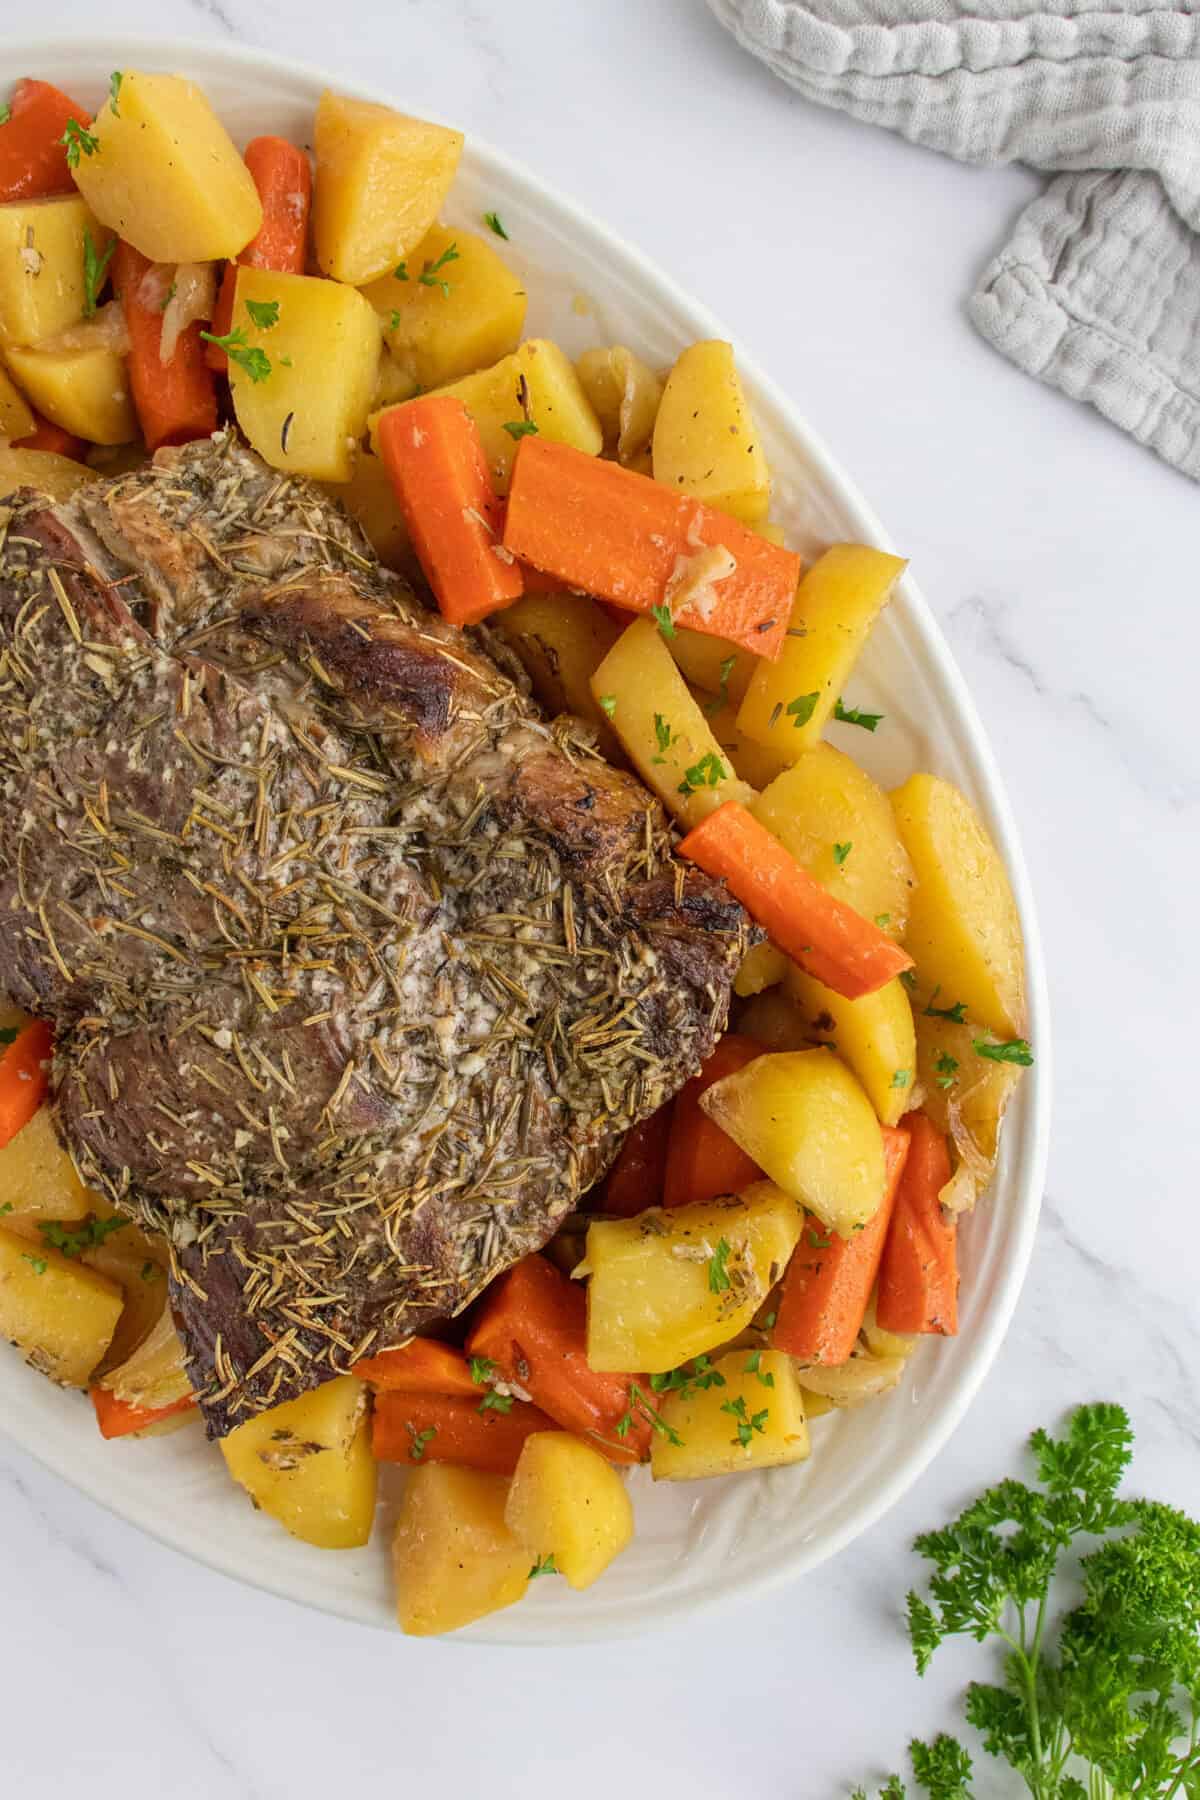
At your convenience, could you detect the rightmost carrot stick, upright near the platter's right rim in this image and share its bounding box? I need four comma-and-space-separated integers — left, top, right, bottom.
874, 1112, 959, 1337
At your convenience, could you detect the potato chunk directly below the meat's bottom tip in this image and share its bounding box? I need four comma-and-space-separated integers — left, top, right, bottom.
221, 1375, 376, 1550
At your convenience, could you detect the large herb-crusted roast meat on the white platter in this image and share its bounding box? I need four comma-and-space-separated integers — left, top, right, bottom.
0, 434, 752, 1435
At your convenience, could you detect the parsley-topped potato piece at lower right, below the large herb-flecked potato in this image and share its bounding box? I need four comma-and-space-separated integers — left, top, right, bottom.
649, 1350, 810, 1481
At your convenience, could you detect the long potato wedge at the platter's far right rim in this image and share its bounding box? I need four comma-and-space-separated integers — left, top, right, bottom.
892, 774, 1025, 1039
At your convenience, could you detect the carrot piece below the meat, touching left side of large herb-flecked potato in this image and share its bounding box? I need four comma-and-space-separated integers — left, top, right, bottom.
466, 1256, 651, 1463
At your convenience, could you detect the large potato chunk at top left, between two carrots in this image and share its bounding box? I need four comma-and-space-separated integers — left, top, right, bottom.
76, 68, 263, 263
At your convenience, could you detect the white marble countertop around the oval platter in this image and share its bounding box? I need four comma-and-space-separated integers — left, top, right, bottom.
0, 0, 1200, 1800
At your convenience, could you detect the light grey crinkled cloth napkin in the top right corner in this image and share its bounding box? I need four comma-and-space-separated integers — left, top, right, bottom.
709, 0, 1200, 481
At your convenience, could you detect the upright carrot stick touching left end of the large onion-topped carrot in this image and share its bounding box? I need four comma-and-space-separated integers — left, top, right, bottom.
380, 394, 524, 625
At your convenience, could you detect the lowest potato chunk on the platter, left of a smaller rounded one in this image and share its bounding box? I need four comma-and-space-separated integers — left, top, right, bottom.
392, 1463, 531, 1638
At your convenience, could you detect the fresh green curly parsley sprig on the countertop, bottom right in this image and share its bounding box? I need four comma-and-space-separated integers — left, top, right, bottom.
853, 1406, 1200, 1800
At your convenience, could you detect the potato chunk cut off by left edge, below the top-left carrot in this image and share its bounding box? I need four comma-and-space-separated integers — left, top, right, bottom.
0, 194, 108, 349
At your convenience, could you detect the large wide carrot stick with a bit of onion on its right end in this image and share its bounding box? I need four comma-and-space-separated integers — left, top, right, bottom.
504, 437, 801, 661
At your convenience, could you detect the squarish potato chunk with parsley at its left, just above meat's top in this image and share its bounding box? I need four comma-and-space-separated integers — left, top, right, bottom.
228, 268, 380, 481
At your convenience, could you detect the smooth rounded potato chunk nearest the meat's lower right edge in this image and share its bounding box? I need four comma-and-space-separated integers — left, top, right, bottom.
698, 1049, 883, 1238
